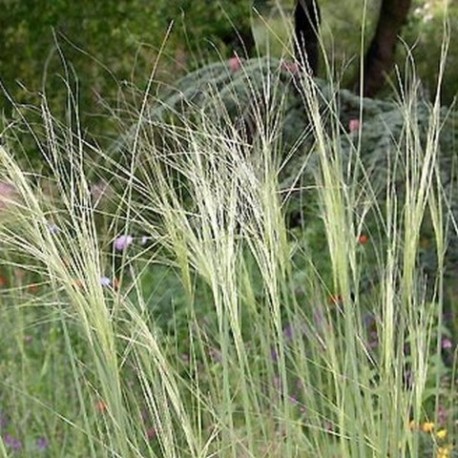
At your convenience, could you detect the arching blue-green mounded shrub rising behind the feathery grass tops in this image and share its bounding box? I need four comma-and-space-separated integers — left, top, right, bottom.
111, 53, 457, 172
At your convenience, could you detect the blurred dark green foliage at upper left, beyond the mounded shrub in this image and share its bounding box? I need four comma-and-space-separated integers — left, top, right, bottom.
0, 0, 254, 167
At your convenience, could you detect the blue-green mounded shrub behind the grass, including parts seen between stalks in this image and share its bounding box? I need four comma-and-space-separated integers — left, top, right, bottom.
109, 54, 458, 308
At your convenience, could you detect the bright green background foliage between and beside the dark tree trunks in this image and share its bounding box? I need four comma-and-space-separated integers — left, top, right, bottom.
255, 0, 458, 105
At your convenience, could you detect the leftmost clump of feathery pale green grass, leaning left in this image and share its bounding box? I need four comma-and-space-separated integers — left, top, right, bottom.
0, 105, 197, 456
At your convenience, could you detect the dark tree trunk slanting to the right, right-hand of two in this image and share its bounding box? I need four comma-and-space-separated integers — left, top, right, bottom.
357, 0, 412, 97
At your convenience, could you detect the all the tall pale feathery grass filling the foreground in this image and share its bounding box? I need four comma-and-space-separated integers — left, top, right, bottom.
0, 48, 452, 458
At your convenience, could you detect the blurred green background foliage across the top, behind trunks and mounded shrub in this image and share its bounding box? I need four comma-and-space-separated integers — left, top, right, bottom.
0, 0, 458, 156
